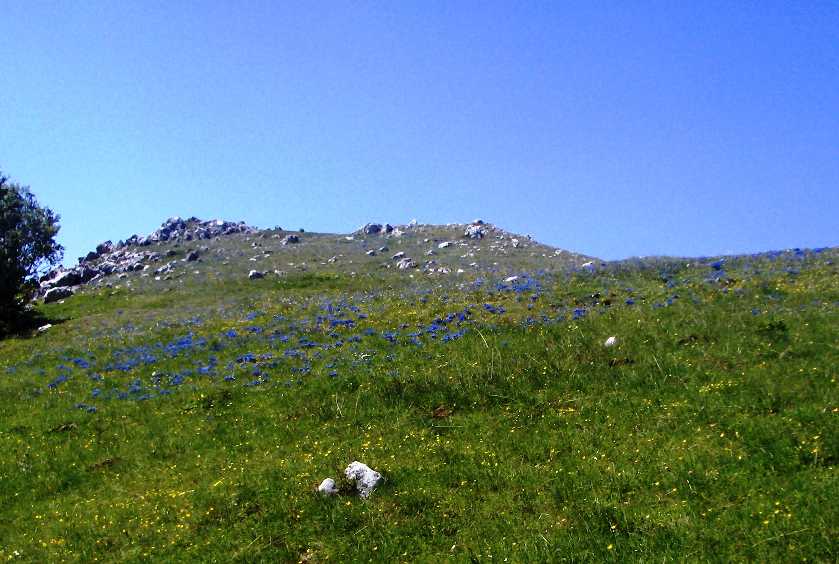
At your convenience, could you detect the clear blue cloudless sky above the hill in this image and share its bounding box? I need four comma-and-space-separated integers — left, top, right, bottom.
0, 0, 839, 263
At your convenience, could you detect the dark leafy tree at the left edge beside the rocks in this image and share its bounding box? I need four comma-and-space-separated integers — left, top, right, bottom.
0, 172, 64, 334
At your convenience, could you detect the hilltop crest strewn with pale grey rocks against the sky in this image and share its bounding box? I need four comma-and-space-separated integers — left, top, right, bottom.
39, 217, 591, 302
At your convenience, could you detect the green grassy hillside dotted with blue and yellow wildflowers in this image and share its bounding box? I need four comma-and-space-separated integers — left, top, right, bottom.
0, 228, 839, 562
